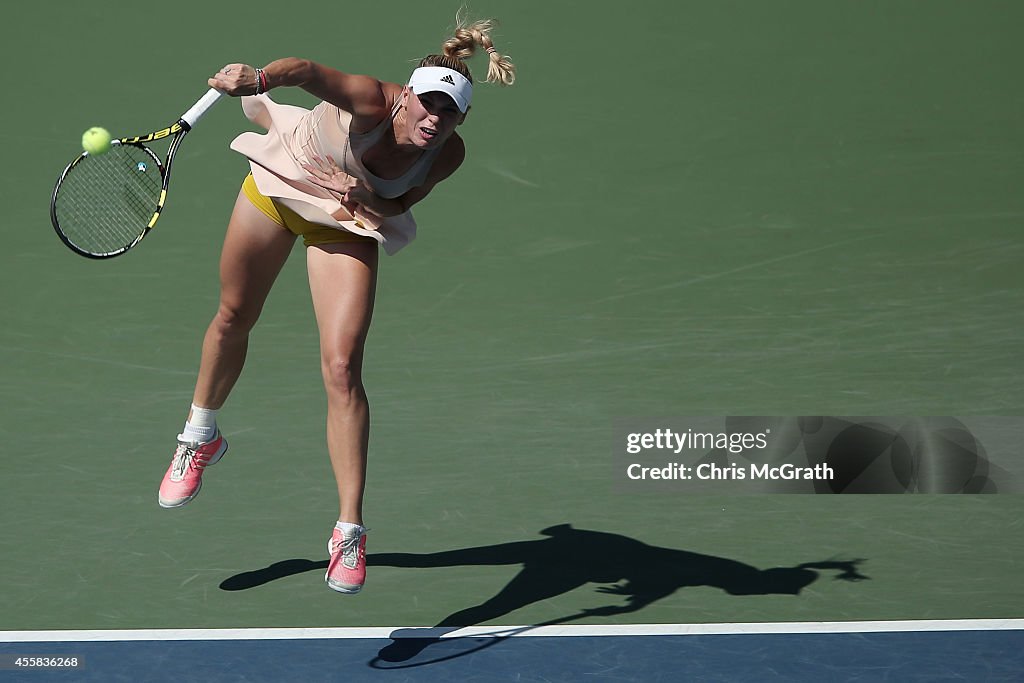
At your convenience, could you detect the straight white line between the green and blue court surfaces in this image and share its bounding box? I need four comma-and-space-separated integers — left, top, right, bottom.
0, 618, 1024, 643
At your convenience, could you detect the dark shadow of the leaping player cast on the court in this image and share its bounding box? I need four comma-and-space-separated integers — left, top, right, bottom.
220, 524, 867, 669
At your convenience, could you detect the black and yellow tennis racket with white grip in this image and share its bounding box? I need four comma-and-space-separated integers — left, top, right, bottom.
50, 88, 223, 258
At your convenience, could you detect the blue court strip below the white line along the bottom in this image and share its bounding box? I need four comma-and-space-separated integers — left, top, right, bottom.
0, 621, 1024, 683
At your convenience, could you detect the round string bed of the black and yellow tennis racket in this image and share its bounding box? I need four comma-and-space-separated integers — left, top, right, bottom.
54, 144, 163, 255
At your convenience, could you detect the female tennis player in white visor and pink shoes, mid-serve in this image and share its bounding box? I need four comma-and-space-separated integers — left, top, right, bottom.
159, 14, 515, 593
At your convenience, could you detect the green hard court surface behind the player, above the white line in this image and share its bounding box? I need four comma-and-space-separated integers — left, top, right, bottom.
0, 0, 1024, 671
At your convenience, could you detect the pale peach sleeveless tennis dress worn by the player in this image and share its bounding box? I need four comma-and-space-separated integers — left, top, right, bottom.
231, 94, 438, 254
